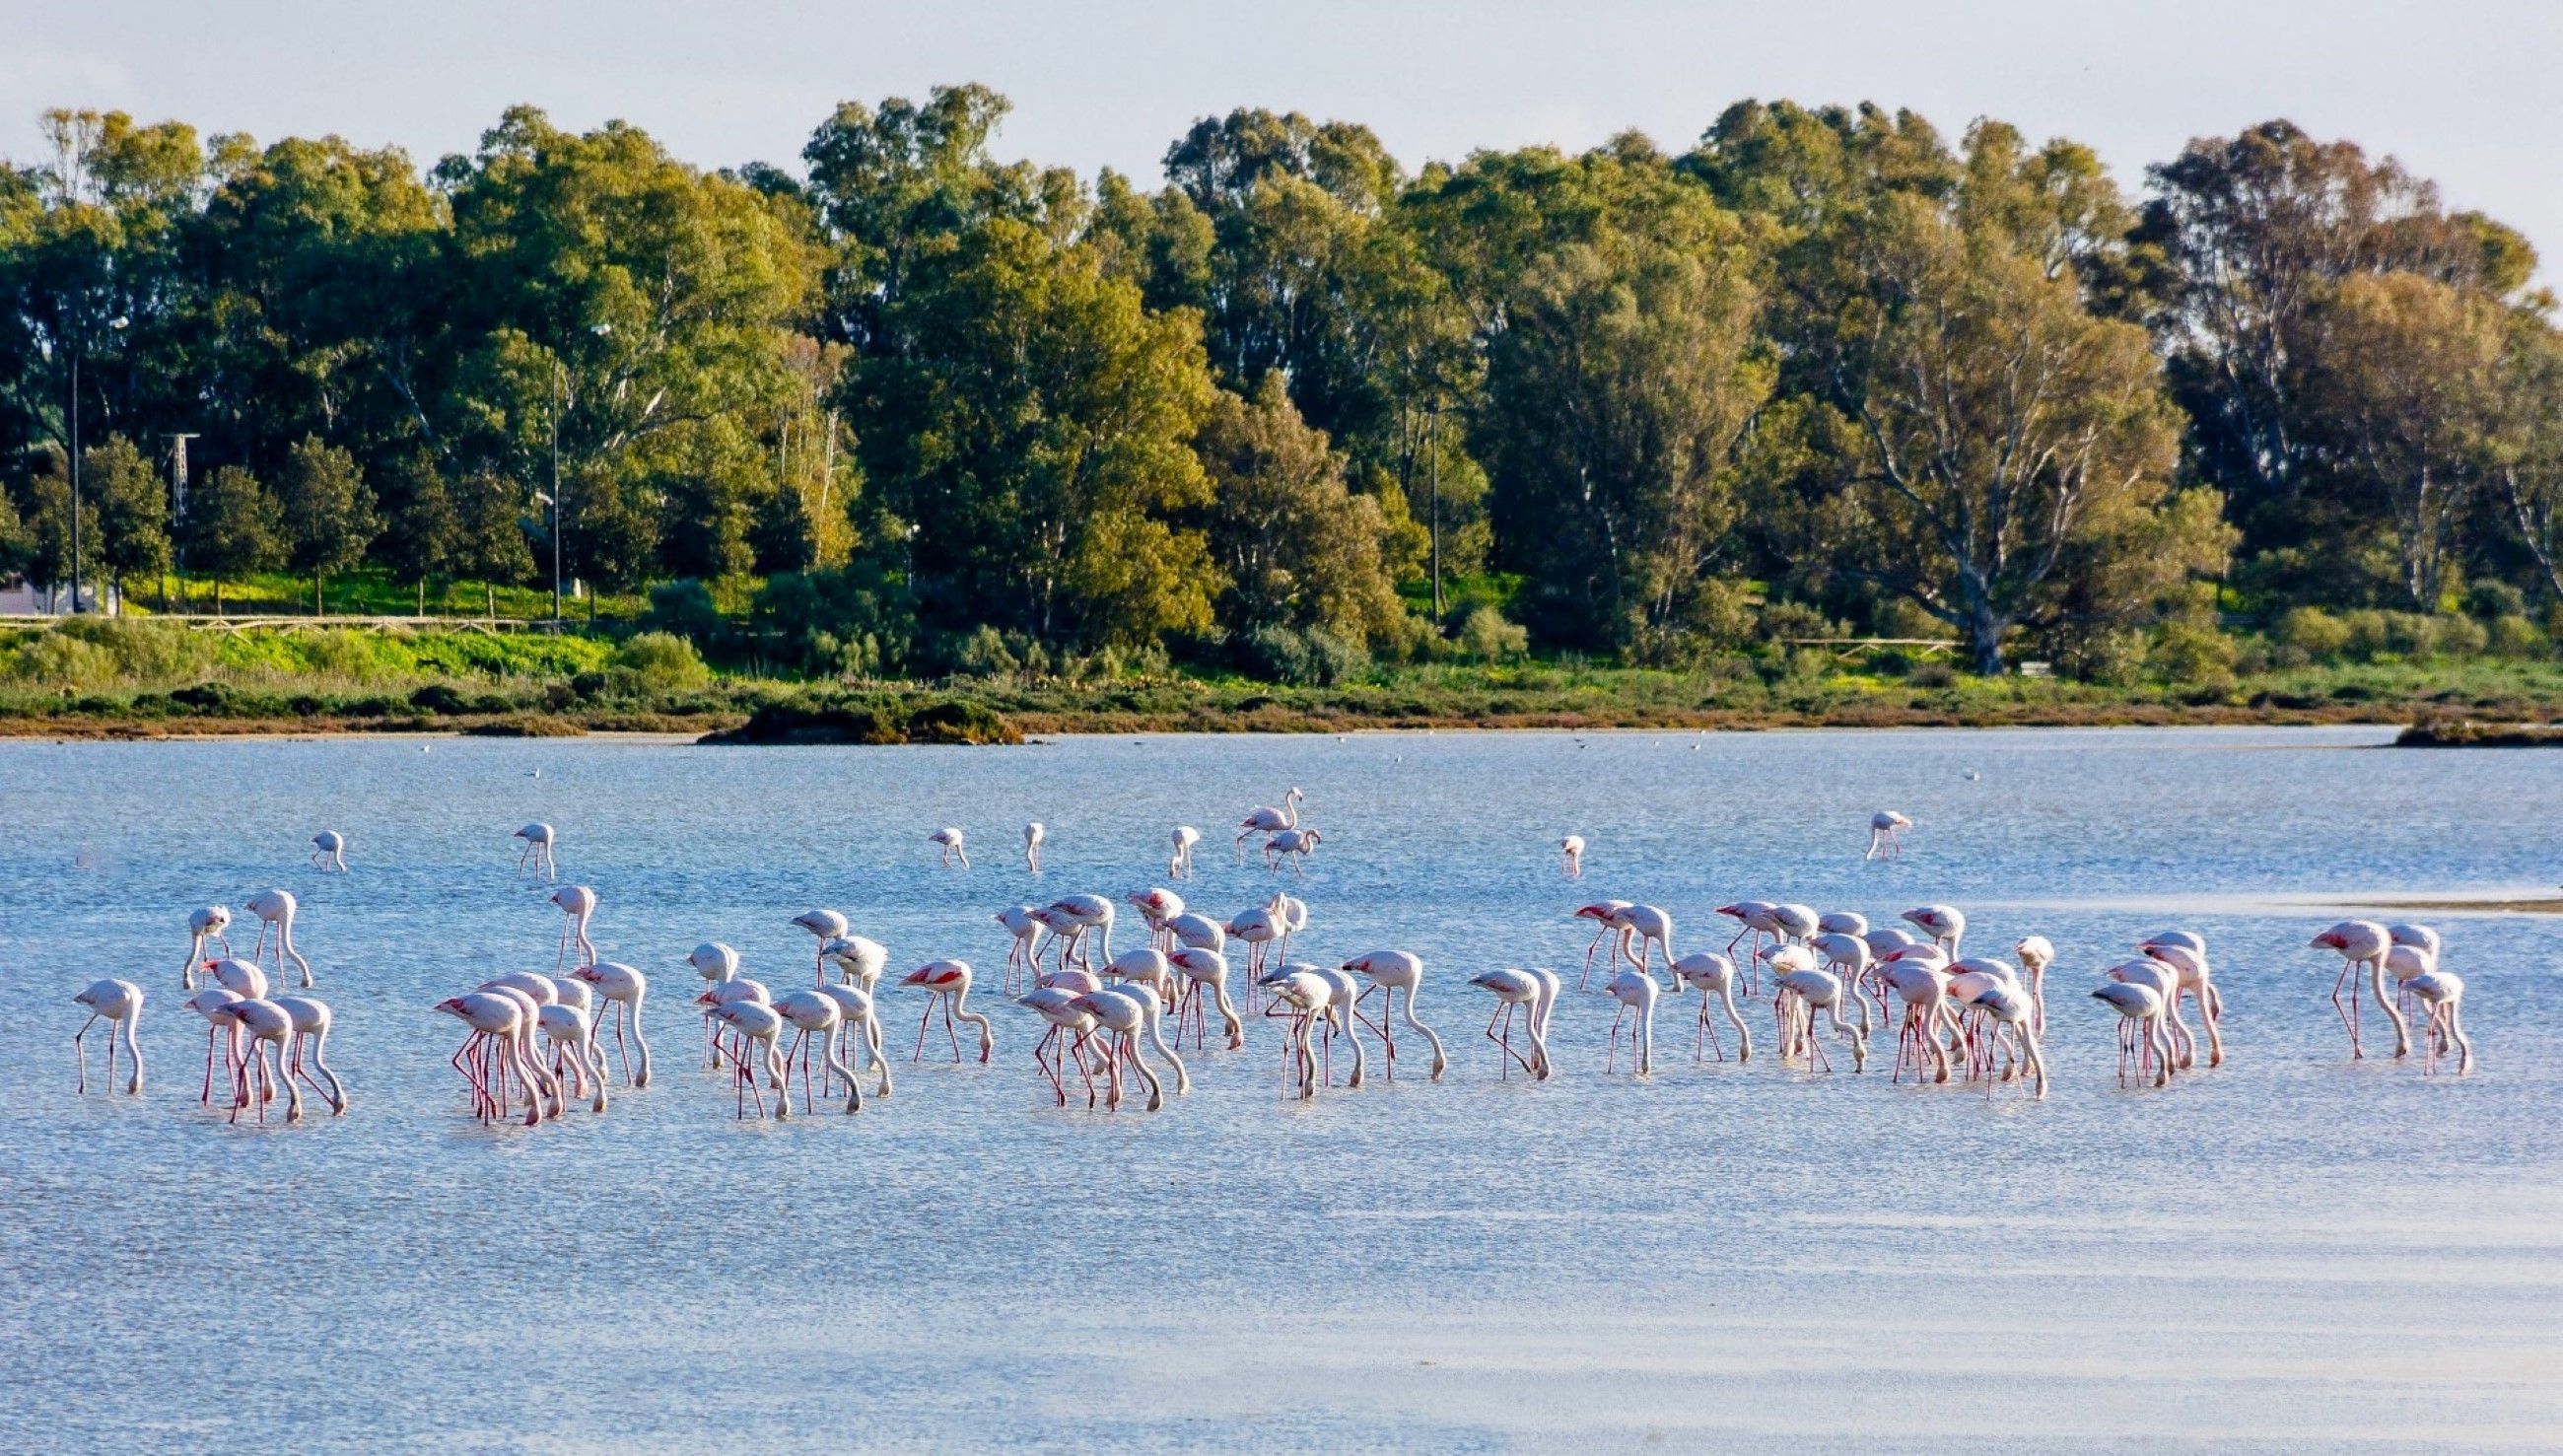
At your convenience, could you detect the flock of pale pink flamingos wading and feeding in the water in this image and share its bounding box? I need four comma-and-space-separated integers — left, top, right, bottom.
72, 787, 2473, 1126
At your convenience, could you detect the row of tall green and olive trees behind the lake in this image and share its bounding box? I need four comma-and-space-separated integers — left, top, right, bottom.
0, 85, 2563, 676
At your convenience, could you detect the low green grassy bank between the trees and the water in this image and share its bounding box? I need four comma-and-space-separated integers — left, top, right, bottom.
15, 620, 2563, 743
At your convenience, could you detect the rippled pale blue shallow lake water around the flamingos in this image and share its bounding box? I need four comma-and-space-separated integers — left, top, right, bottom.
0, 730, 2563, 1451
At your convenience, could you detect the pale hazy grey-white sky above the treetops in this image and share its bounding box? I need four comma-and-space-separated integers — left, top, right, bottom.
0, 0, 2563, 245
